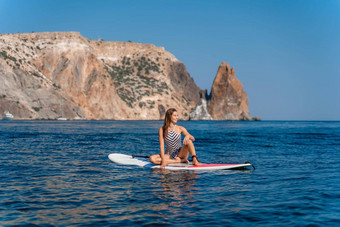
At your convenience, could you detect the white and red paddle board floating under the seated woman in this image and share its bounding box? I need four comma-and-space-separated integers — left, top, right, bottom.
109, 153, 252, 171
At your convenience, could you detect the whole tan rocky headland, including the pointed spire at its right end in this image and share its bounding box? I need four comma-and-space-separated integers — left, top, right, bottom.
0, 32, 255, 120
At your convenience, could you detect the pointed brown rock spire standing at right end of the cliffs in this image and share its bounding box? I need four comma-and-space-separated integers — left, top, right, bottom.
208, 62, 251, 120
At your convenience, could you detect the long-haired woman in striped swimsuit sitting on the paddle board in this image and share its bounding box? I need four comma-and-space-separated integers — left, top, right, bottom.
150, 108, 199, 168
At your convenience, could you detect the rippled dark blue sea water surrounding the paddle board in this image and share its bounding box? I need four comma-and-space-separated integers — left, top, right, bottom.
0, 121, 340, 226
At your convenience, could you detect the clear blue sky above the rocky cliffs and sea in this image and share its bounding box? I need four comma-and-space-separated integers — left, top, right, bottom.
0, 0, 340, 120
